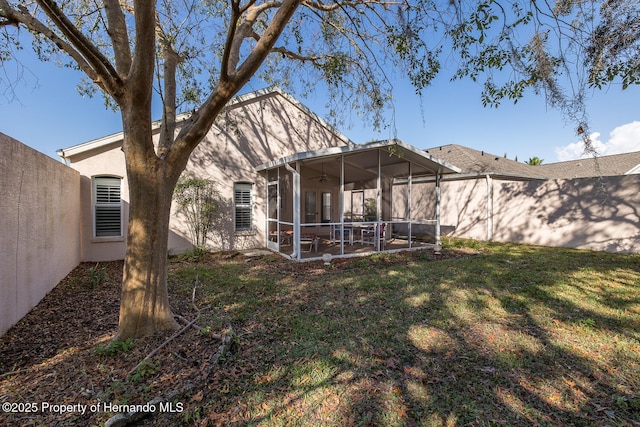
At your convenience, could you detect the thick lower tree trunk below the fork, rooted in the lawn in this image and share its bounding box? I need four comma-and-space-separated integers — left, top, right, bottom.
116, 113, 186, 340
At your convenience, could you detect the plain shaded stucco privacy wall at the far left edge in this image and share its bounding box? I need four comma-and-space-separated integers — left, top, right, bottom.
0, 133, 80, 335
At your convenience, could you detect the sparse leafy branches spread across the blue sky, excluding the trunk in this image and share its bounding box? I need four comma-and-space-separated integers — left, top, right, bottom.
0, 0, 640, 137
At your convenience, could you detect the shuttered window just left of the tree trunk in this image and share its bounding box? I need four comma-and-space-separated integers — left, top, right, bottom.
93, 176, 122, 237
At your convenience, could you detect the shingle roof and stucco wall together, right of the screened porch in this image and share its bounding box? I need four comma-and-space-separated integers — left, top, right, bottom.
415, 144, 640, 253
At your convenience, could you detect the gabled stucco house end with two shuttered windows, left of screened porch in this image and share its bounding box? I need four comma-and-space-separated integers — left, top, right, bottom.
58, 88, 351, 261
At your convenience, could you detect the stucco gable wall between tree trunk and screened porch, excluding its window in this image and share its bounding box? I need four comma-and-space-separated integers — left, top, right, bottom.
179, 93, 345, 250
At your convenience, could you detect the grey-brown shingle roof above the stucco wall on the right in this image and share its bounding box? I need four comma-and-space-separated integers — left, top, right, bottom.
425, 144, 640, 179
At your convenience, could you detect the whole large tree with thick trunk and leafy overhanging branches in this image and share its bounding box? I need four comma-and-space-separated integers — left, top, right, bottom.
0, 0, 640, 339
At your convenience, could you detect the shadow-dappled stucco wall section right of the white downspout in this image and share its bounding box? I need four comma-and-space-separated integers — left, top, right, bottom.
493, 175, 640, 253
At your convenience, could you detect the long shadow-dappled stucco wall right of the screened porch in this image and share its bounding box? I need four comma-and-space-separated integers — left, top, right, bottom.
419, 175, 640, 253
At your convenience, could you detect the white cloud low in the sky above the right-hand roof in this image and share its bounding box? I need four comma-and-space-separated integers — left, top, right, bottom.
555, 121, 640, 162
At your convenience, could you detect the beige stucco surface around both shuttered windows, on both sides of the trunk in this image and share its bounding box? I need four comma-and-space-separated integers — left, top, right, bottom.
67, 92, 345, 261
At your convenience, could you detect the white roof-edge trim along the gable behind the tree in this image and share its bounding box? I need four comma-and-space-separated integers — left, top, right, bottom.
56, 86, 355, 159
